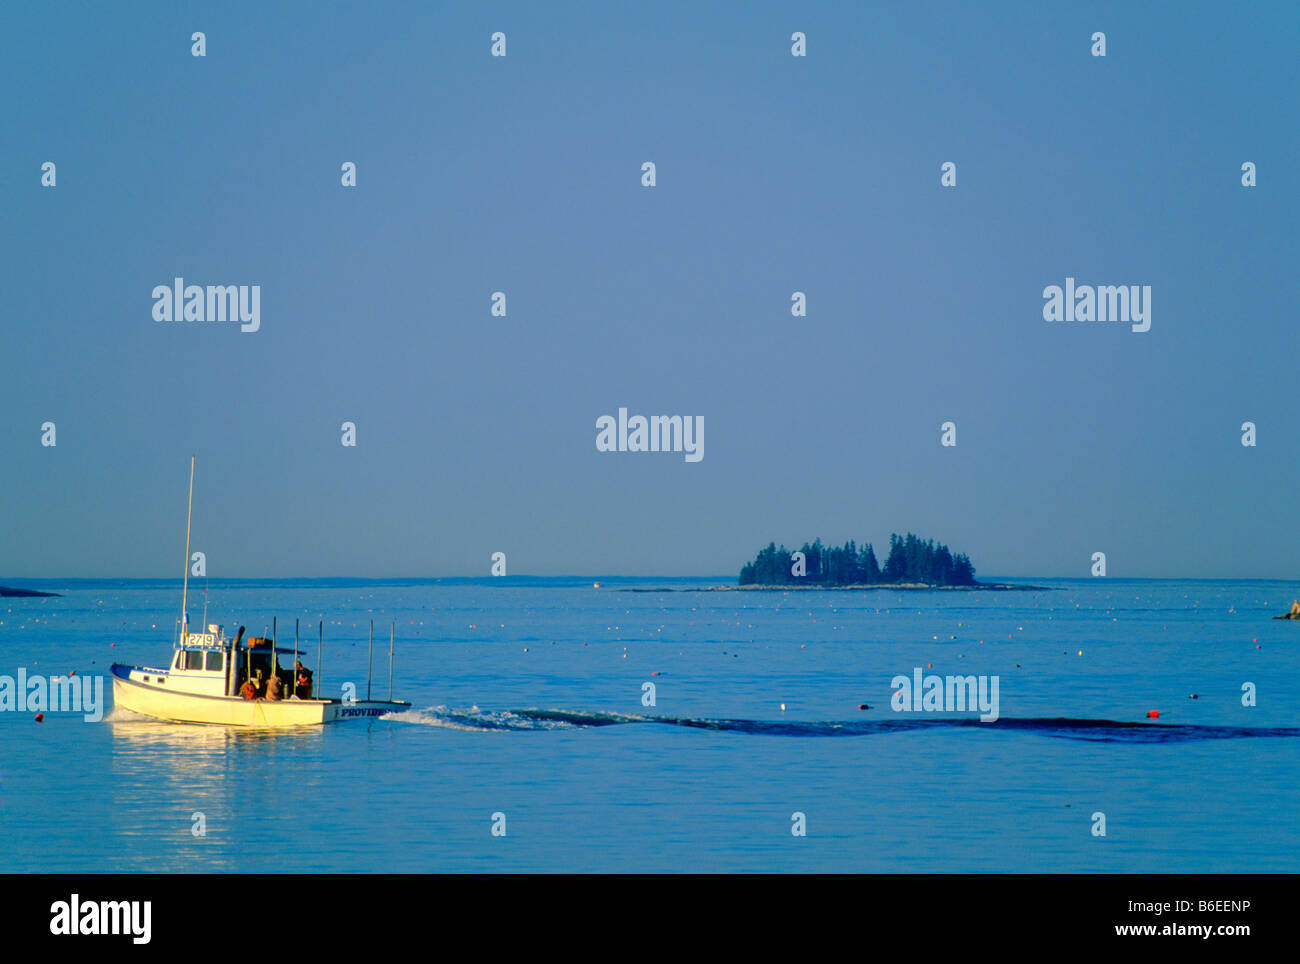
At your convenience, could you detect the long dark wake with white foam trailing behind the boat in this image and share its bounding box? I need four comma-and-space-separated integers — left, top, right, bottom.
382, 707, 1300, 743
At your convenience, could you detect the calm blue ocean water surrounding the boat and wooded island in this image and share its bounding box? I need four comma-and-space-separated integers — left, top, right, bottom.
0, 578, 1300, 872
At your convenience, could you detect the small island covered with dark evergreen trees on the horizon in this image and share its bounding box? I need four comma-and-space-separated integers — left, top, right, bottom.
737, 533, 1037, 589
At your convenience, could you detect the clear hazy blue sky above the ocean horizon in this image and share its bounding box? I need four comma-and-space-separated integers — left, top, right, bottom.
0, 3, 1300, 577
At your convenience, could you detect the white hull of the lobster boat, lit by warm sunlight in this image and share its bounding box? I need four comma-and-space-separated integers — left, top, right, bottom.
113, 665, 411, 728
